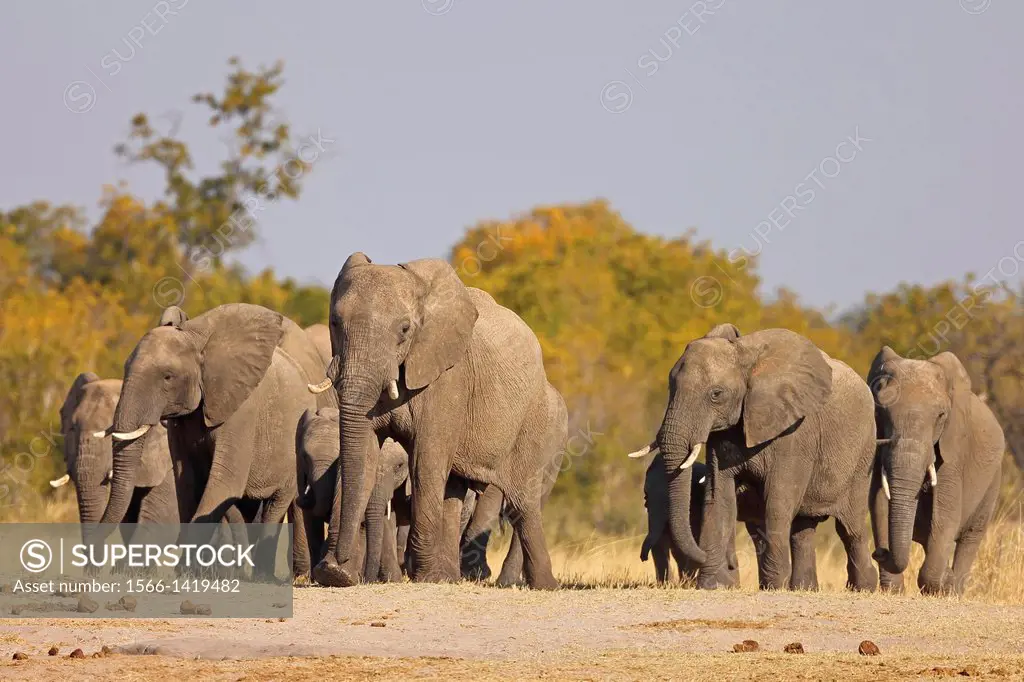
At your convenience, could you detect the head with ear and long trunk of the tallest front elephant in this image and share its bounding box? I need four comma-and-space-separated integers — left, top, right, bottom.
310, 253, 477, 584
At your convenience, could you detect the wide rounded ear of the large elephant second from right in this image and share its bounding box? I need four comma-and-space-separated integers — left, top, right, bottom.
736, 329, 831, 447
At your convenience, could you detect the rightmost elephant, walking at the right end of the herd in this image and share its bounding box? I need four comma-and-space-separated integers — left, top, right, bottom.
868, 346, 1006, 594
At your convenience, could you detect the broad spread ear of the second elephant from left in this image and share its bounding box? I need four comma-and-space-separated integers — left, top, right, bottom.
190, 303, 285, 427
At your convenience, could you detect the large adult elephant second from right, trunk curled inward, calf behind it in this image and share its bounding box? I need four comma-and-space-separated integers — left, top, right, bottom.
626, 325, 878, 590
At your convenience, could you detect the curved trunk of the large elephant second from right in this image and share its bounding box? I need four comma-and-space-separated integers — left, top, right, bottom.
657, 404, 710, 564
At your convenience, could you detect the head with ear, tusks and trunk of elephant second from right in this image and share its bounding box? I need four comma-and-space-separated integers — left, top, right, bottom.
633, 325, 831, 563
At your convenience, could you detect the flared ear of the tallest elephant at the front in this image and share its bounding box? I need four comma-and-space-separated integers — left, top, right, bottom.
401, 259, 478, 389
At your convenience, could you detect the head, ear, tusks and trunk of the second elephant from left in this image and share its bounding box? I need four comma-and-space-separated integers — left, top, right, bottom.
102, 303, 285, 523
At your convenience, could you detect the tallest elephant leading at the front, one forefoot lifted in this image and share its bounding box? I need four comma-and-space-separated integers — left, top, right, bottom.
311, 253, 565, 589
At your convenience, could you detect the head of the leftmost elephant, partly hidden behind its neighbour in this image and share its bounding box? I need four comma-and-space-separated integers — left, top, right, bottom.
50, 372, 171, 523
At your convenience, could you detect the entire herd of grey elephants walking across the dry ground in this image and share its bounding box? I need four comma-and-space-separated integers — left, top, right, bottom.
51, 253, 1004, 592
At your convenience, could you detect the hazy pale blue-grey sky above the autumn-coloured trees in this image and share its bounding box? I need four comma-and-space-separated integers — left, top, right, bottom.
0, 0, 1024, 308
